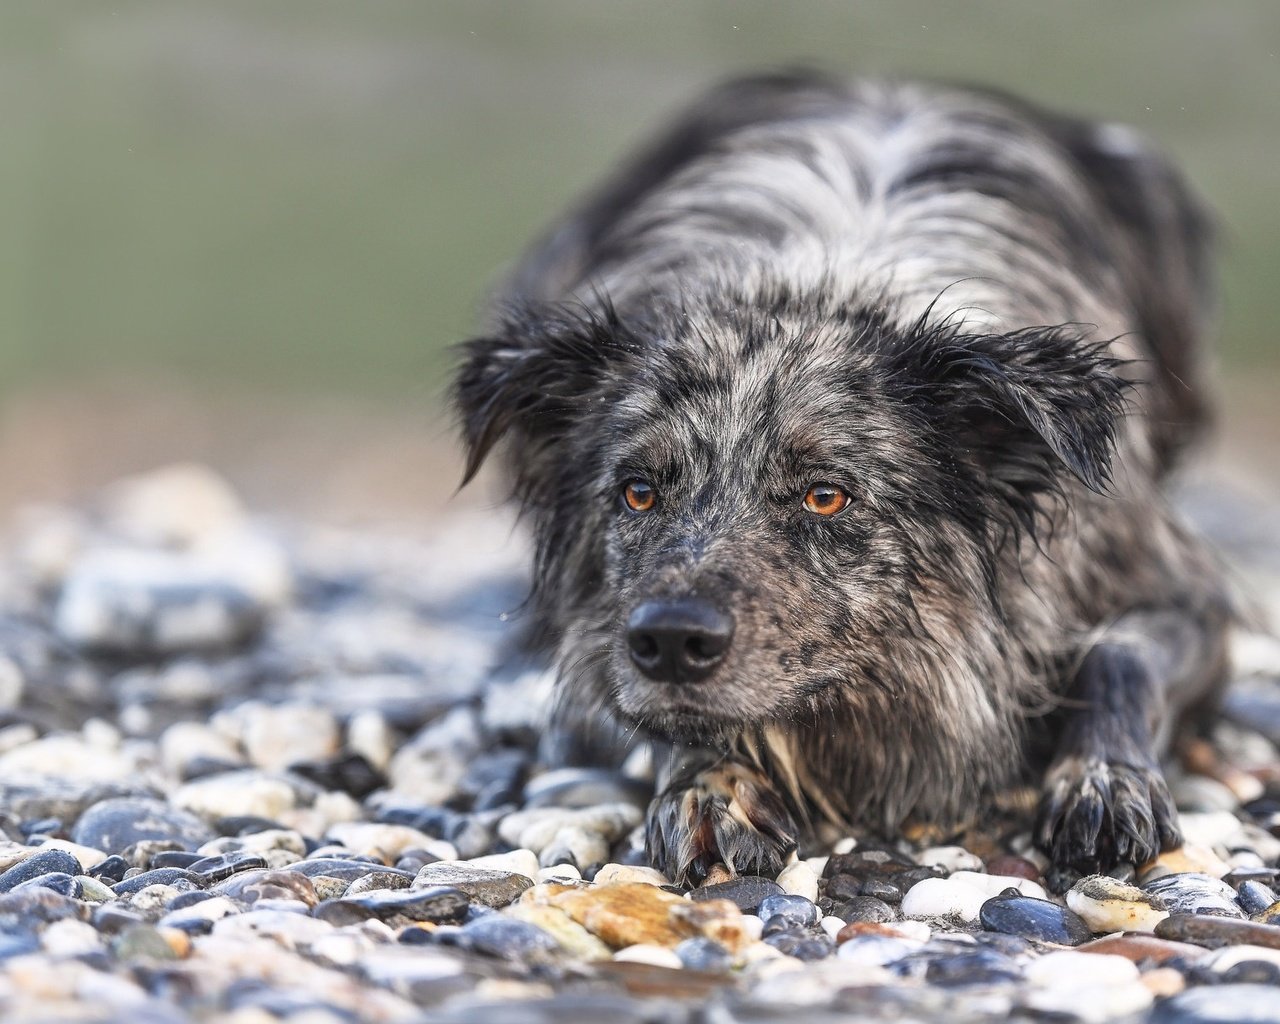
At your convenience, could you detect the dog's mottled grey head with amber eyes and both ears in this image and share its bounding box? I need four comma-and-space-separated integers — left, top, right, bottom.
456, 298, 1124, 741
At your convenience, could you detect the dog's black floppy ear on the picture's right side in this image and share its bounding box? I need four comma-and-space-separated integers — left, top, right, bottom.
911, 325, 1130, 502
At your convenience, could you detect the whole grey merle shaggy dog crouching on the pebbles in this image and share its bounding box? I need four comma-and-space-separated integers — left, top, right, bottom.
456, 74, 1231, 886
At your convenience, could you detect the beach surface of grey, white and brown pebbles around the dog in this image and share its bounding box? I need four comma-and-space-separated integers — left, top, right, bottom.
0, 466, 1280, 1024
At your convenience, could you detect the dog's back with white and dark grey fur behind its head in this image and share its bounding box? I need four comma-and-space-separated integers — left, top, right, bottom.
498, 74, 1212, 471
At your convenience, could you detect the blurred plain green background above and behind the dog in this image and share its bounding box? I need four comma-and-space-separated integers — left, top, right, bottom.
0, 0, 1280, 517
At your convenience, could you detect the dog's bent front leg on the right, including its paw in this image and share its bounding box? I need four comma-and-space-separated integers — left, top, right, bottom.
1037, 607, 1226, 890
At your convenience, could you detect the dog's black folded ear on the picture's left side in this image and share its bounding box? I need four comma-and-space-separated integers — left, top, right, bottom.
453, 305, 636, 484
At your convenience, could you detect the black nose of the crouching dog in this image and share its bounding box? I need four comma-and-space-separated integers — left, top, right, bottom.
627, 598, 733, 682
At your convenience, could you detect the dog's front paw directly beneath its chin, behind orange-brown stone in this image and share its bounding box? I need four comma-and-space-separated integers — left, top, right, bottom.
645, 762, 797, 886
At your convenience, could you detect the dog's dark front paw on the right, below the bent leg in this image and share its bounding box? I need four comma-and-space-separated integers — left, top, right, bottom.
1036, 758, 1181, 890
